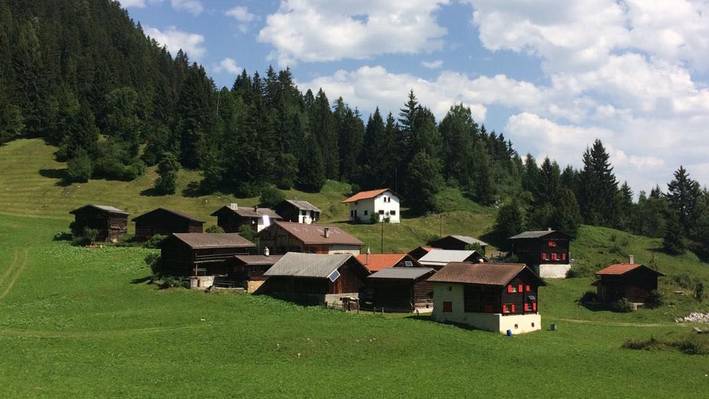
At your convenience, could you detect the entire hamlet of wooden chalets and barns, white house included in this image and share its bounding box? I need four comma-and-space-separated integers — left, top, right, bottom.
71, 189, 661, 334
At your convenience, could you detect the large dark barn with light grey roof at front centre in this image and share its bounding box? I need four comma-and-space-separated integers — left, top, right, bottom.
258, 252, 369, 305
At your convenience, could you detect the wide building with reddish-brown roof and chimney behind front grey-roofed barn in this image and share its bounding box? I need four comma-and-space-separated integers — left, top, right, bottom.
259, 221, 364, 255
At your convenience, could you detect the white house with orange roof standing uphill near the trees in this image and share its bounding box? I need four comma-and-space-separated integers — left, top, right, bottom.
342, 188, 401, 223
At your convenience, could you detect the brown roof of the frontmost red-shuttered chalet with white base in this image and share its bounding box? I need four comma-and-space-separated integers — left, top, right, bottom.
428, 263, 544, 285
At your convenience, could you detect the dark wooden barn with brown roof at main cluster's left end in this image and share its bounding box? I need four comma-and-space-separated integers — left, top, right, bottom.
160, 233, 256, 276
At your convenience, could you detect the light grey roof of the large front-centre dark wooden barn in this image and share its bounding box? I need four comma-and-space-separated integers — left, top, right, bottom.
263, 252, 352, 278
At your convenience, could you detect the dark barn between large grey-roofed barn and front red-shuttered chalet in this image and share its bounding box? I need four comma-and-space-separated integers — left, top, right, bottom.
361, 267, 436, 312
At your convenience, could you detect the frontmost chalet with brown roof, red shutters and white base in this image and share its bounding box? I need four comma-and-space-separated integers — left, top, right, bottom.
428, 263, 544, 334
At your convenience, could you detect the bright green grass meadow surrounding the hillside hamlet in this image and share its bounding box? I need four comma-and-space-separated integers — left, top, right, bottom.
0, 140, 709, 398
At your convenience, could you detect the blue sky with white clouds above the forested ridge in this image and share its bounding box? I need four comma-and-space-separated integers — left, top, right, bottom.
120, 0, 709, 194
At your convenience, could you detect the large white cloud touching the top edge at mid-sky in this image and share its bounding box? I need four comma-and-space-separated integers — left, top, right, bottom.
259, 0, 448, 65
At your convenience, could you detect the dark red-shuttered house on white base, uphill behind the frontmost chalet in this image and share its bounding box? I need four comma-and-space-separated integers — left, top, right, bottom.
510, 229, 571, 278
